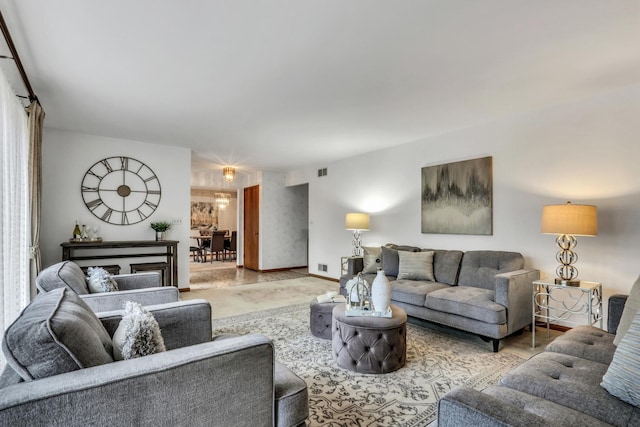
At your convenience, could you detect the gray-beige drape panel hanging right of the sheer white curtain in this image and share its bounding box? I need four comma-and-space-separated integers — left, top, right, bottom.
27, 101, 44, 297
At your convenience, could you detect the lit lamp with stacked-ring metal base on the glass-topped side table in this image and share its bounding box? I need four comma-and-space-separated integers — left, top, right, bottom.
542, 202, 598, 286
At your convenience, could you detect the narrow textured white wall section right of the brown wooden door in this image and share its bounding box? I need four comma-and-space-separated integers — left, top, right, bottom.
260, 172, 309, 270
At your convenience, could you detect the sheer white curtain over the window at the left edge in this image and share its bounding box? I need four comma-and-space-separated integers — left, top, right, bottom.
0, 70, 31, 342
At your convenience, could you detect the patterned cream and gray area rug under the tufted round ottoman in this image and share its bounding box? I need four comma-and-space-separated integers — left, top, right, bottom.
213, 303, 524, 427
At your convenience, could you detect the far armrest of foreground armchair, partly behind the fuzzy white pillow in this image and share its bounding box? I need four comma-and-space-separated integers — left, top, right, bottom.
96, 299, 212, 350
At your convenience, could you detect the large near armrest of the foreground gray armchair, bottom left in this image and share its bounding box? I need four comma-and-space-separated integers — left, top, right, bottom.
0, 334, 274, 426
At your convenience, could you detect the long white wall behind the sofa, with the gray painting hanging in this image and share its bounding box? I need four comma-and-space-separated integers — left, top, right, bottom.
298, 86, 640, 322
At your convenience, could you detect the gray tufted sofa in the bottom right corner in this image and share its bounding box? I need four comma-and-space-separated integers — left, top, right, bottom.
438, 290, 640, 427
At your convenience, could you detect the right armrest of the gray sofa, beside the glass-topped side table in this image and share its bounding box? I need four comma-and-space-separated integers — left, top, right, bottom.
495, 270, 540, 334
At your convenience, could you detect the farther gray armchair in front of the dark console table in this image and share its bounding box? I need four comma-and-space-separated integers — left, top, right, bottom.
36, 261, 179, 312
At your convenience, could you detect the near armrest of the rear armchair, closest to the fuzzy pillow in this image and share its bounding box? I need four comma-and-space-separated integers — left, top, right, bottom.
80, 286, 180, 313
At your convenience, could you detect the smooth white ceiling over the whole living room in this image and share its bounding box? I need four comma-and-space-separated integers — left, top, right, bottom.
0, 0, 640, 176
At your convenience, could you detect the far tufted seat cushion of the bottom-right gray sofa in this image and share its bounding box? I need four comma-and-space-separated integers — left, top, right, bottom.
546, 325, 616, 365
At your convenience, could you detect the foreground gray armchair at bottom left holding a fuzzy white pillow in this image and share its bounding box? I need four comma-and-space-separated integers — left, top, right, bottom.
0, 288, 308, 427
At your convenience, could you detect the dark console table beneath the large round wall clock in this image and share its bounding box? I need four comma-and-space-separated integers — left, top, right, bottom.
60, 240, 178, 287
